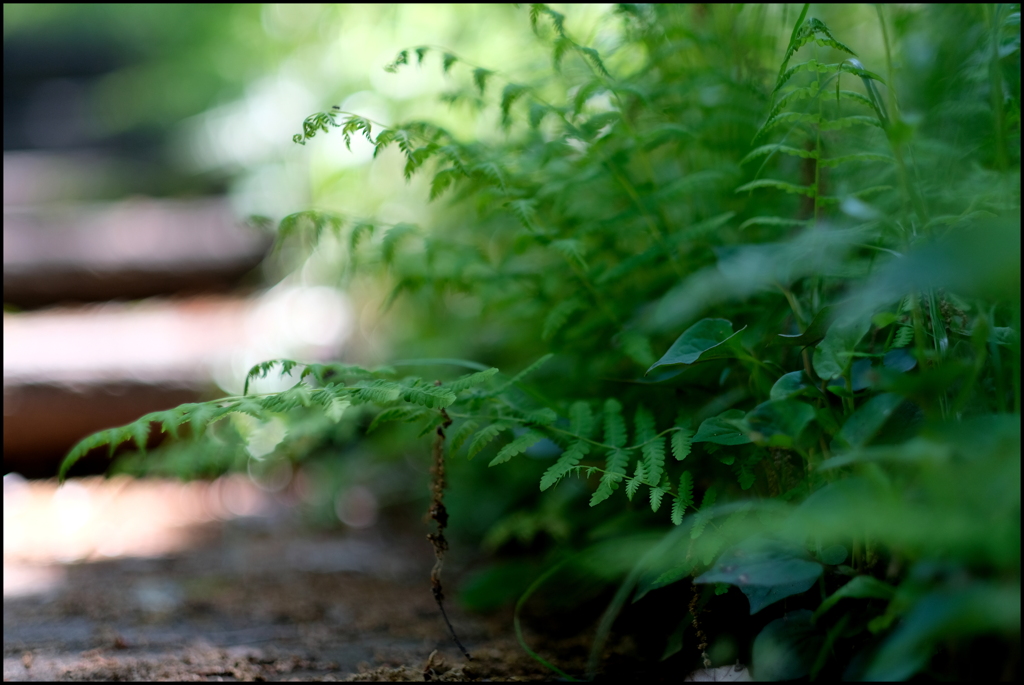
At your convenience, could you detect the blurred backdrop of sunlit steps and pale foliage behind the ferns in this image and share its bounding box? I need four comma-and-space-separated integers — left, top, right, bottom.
3, 4, 552, 594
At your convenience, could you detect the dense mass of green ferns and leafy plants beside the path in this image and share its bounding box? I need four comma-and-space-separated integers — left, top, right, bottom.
65, 5, 1020, 680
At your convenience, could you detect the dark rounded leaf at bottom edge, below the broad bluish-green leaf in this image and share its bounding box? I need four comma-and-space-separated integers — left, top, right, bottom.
752, 609, 824, 681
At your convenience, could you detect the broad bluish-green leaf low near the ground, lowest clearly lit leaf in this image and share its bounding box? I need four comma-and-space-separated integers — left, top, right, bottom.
693, 536, 822, 615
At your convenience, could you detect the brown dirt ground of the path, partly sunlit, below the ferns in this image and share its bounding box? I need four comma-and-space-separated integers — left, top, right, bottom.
4, 480, 602, 681
